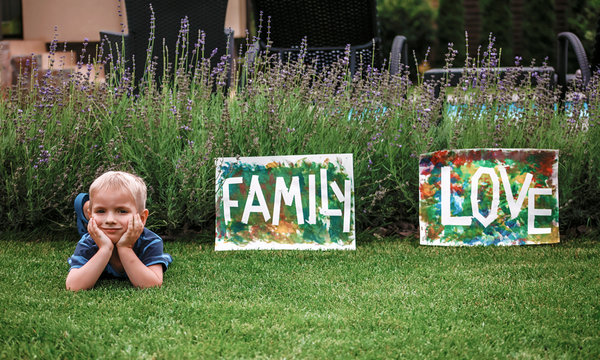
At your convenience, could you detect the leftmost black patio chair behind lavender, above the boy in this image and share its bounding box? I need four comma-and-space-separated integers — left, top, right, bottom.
100, 0, 233, 84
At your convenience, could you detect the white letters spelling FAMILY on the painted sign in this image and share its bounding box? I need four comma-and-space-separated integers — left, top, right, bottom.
222, 169, 352, 233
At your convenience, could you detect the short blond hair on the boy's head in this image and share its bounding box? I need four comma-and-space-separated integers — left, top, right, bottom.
89, 171, 147, 211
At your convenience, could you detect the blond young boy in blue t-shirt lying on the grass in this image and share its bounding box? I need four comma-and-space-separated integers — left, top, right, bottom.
66, 171, 173, 291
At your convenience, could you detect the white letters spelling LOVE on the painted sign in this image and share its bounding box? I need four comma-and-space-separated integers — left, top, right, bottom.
441, 166, 552, 235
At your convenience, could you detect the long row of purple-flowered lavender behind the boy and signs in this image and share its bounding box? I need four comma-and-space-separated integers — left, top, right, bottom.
0, 27, 600, 236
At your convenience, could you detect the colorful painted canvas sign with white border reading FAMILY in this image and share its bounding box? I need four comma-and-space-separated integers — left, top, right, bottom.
215, 154, 356, 250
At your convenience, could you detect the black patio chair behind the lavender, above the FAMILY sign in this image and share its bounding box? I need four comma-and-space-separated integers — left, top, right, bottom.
252, 0, 408, 74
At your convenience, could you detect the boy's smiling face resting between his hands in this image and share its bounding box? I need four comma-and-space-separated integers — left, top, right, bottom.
90, 189, 148, 244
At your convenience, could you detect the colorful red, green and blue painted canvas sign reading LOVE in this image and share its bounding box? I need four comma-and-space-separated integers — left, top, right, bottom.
419, 149, 560, 246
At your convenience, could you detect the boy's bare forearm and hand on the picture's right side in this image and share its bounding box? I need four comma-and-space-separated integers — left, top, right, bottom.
117, 214, 163, 288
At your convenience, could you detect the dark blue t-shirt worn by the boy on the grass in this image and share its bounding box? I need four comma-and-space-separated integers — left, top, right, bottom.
68, 228, 173, 278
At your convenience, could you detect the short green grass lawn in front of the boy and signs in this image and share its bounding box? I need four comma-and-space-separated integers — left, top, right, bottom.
0, 233, 600, 359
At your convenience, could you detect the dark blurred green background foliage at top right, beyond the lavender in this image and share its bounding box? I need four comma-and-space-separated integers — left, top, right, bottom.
377, 0, 600, 73
